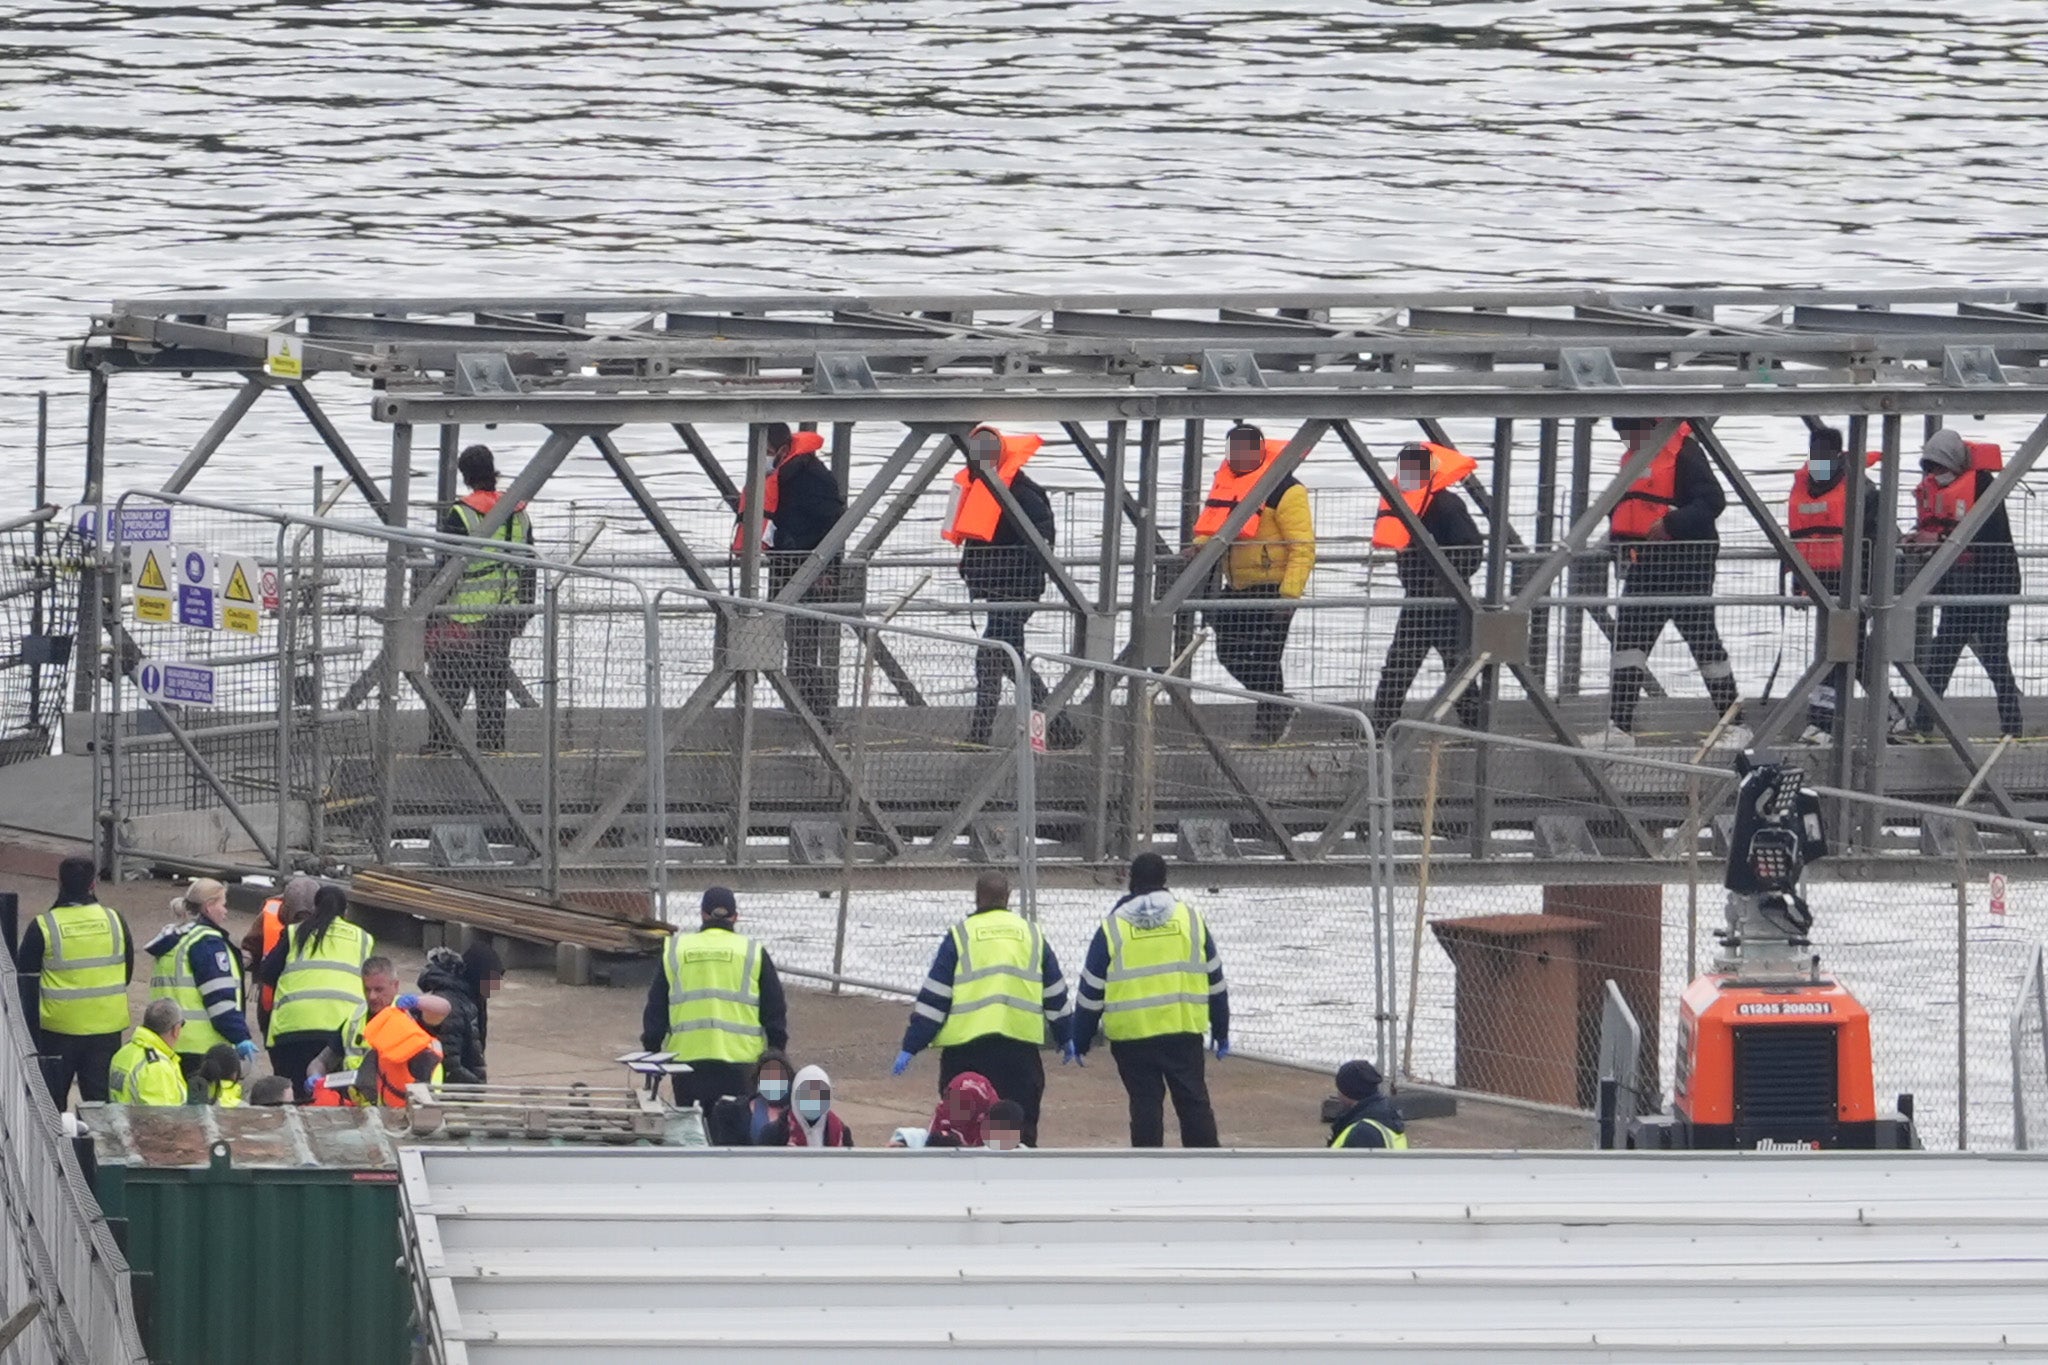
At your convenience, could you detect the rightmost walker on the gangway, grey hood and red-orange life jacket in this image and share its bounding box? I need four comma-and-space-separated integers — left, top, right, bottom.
1909, 430, 2023, 735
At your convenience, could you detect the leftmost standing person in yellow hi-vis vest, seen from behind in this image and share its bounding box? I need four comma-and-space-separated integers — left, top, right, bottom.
14, 857, 135, 1109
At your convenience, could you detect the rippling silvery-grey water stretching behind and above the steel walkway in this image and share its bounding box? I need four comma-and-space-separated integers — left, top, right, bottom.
0, 0, 2048, 497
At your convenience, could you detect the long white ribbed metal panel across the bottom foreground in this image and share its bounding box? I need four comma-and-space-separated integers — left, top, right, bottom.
401, 1148, 2048, 1365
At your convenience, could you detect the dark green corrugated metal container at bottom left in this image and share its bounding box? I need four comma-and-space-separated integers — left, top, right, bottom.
80, 1105, 414, 1365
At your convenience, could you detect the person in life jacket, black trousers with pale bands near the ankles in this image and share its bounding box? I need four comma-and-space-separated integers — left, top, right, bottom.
1587, 417, 1749, 749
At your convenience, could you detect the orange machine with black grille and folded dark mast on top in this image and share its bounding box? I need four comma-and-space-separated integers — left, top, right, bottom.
1628, 755, 1919, 1150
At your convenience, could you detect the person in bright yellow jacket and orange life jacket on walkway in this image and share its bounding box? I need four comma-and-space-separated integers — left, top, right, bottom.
1184, 424, 1315, 745
